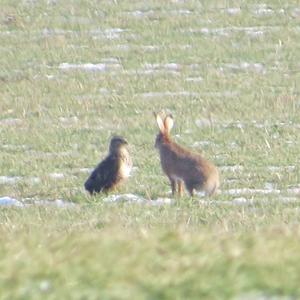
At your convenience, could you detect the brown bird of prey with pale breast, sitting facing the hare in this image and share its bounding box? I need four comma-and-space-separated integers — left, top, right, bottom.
84, 136, 132, 195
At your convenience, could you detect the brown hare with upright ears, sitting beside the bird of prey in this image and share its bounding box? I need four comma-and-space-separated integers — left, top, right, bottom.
154, 113, 220, 196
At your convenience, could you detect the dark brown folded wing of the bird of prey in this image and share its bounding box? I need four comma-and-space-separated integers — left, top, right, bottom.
85, 155, 119, 194
